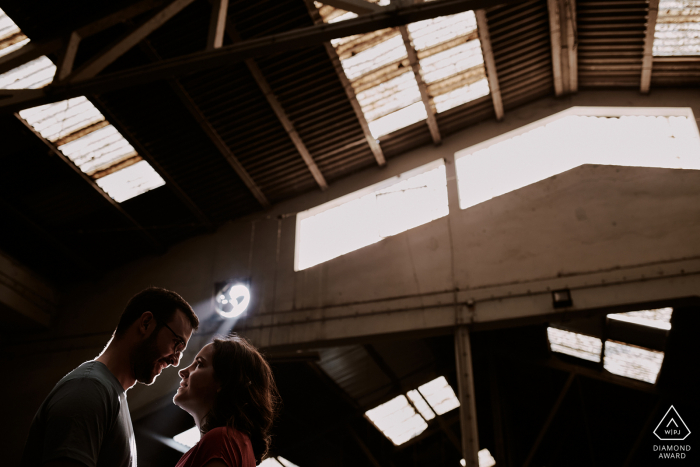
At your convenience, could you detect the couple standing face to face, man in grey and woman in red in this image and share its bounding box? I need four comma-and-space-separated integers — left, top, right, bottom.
21, 287, 278, 467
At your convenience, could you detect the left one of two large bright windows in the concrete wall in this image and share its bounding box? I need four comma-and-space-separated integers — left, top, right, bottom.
294, 159, 449, 271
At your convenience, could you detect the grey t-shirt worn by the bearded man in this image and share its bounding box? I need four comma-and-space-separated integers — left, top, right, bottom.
21, 361, 136, 467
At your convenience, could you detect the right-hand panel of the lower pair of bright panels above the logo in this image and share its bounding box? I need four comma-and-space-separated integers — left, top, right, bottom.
603, 341, 664, 384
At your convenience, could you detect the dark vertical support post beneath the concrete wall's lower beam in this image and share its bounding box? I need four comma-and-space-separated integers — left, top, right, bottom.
455, 326, 479, 467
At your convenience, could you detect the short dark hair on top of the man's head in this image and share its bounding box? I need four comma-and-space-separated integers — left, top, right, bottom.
114, 287, 199, 336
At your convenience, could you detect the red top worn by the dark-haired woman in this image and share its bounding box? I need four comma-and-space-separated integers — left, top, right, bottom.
175, 427, 255, 467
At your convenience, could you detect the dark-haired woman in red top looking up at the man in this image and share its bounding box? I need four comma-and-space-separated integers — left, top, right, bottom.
173, 336, 278, 467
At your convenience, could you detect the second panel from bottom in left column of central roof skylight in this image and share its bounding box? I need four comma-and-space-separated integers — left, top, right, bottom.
357, 71, 421, 122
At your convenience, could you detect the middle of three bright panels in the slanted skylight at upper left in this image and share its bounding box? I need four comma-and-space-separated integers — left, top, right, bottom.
60, 125, 137, 175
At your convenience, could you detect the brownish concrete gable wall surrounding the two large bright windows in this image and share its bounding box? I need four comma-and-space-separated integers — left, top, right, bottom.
2, 90, 700, 459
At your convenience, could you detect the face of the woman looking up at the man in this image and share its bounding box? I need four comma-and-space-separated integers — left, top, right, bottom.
173, 344, 220, 418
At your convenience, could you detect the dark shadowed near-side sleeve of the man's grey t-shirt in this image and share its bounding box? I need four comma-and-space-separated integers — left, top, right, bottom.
41, 379, 119, 467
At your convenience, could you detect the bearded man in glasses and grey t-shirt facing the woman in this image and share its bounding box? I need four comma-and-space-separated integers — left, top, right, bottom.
21, 287, 199, 467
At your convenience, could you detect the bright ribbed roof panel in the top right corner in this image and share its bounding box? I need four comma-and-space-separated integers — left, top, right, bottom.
653, 0, 700, 56
